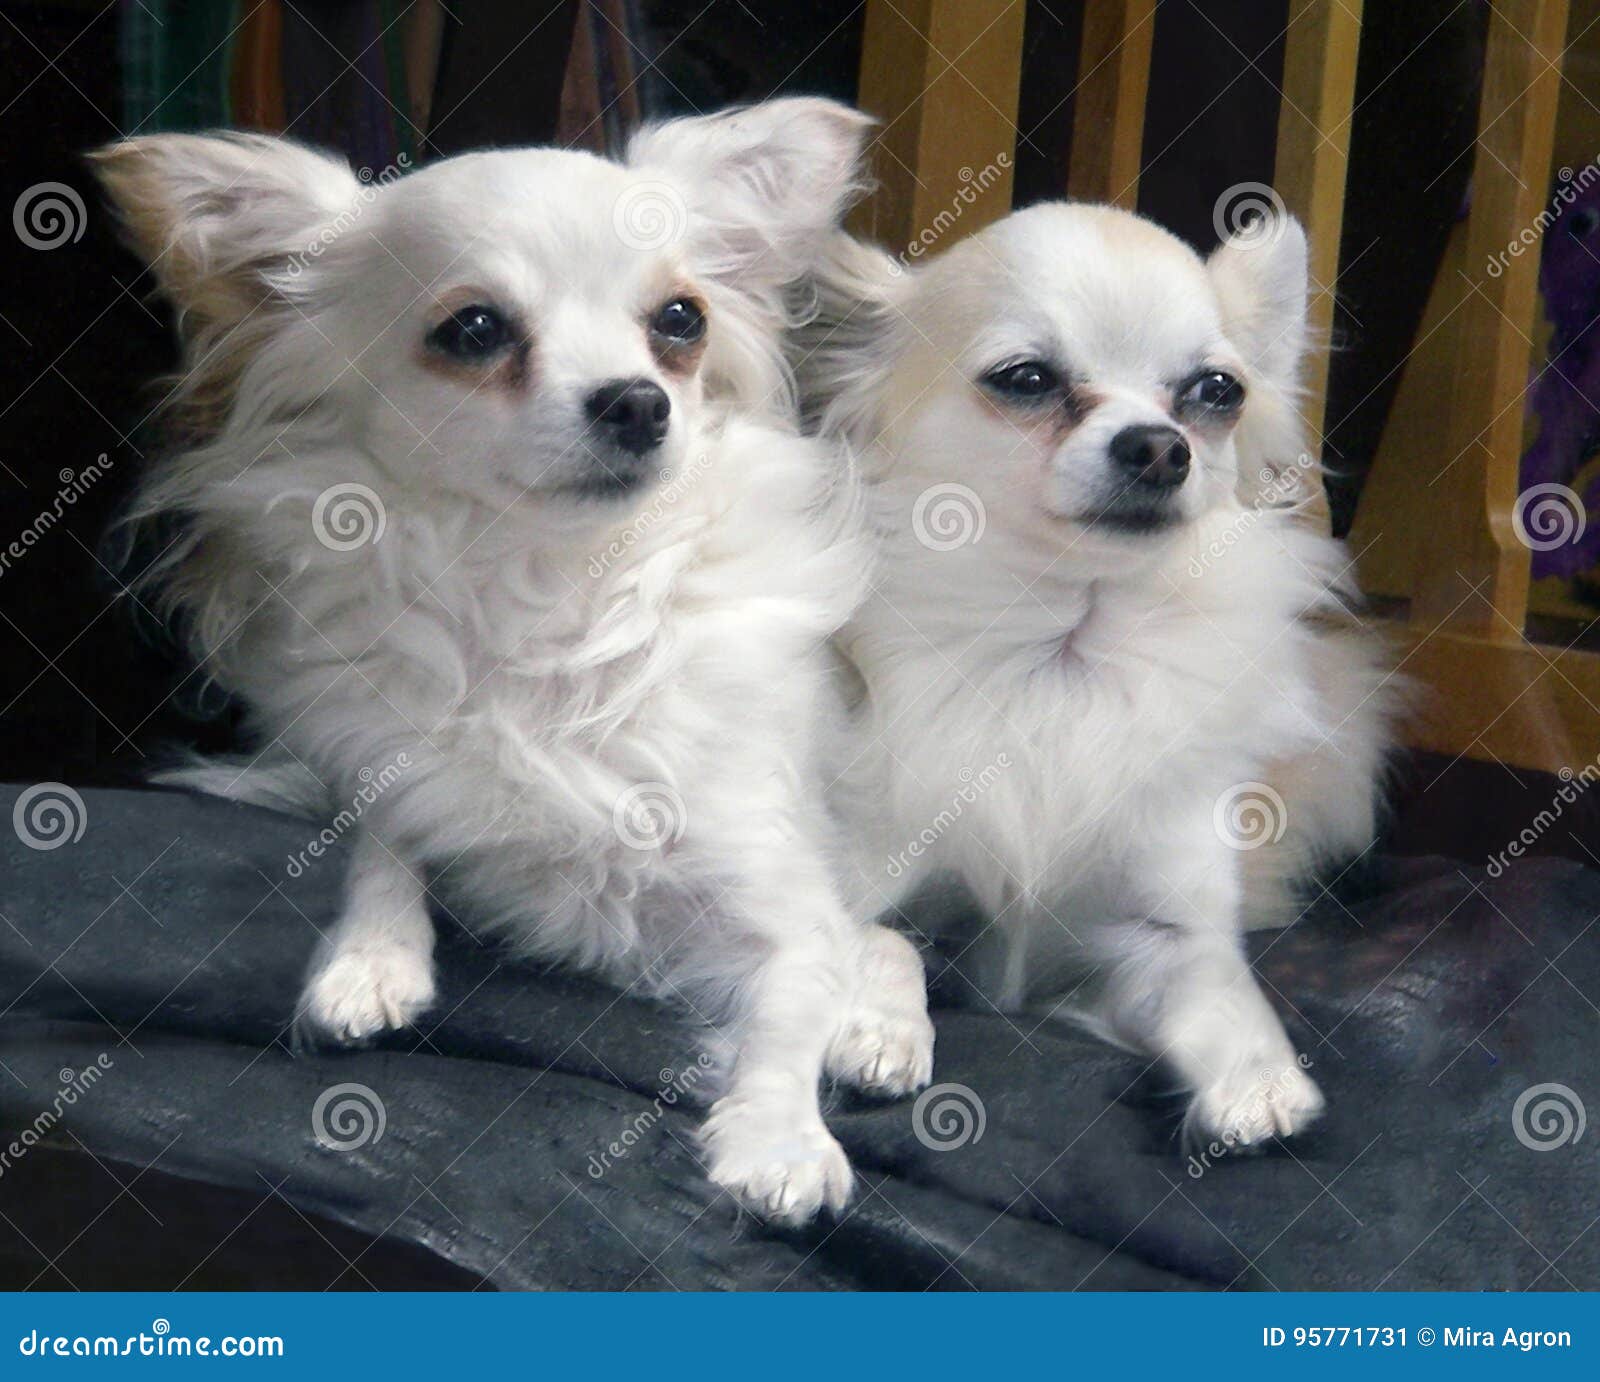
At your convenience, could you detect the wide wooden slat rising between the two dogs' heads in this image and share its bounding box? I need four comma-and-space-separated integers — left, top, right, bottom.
851, 0, 1026, 254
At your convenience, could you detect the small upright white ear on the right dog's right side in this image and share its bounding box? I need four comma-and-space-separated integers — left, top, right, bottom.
1206, 216, 1307, 390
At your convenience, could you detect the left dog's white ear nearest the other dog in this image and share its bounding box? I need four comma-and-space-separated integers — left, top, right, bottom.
627, 96, 872, 293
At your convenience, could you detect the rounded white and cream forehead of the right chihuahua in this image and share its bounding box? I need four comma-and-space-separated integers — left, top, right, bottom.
963, 203, 1222, 374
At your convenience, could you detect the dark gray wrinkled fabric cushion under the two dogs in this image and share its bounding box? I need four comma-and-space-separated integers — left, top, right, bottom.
0, 789, 1600, 1289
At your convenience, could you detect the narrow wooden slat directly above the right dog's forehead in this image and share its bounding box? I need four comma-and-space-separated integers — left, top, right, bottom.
1067, 0, 1155, 211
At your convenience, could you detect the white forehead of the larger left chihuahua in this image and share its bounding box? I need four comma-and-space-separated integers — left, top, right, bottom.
376, 149, 670, 291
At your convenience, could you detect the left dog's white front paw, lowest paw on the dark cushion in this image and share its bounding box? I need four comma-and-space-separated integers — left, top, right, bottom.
701, 1097, 854, 1227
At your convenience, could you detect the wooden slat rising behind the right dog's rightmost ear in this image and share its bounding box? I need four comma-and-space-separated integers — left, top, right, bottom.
1274, 0, 1362, 528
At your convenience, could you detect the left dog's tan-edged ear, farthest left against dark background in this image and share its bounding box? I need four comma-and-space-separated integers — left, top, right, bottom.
91, 134, 362, 330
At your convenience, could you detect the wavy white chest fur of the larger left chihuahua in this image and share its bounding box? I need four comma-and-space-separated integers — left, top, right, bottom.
233, 422, 867, 968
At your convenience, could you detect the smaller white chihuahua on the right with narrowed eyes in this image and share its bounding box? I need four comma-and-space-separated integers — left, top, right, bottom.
802, 205, 1390, 1145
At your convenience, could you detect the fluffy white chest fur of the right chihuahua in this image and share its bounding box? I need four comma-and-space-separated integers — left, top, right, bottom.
851, 502, 1326, 909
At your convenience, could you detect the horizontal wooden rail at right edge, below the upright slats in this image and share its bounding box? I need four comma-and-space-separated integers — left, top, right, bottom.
1400, 625, 1600, 773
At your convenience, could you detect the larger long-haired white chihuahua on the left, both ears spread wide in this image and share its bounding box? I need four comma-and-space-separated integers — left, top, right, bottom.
99, 99, 931, 1220
